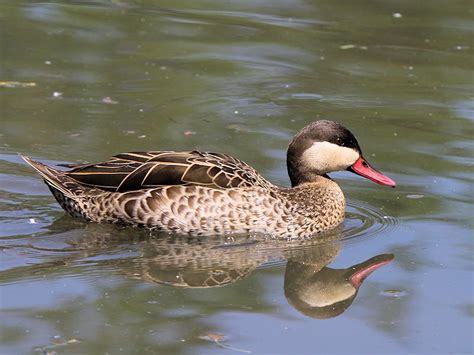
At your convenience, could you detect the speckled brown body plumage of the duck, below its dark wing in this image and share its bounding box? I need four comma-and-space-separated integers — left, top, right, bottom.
21, 154, 345, 237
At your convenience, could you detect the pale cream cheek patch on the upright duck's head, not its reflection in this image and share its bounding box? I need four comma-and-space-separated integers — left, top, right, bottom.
302, 142, 359, 174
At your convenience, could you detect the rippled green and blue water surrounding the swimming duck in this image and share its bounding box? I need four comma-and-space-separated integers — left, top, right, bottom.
0, 0, 474, 354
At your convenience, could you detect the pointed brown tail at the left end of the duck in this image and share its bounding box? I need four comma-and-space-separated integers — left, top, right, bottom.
20, 155, 80, 199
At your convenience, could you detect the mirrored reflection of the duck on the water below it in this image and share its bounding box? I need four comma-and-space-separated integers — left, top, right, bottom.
65, 228, 394, 319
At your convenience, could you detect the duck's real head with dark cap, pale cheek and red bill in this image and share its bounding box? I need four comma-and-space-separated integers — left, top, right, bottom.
287, 121, 396, 187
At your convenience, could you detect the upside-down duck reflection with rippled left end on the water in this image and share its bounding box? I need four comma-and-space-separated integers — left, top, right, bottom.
14, 218, 394, 319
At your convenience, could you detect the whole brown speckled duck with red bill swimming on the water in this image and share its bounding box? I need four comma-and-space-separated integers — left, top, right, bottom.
22, 120, 396, 238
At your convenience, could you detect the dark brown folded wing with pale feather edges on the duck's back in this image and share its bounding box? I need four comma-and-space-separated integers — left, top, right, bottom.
65, 151, 272, 192
